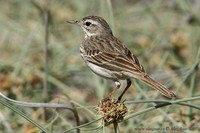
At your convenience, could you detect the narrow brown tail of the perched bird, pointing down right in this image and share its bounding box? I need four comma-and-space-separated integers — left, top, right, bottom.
141, 75, 176, 98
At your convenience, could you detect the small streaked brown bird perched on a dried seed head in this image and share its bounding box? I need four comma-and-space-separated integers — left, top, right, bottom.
67, 16, 176, 101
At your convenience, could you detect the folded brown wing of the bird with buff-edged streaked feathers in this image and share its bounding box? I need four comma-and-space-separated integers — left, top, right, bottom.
82, 37, 144, 73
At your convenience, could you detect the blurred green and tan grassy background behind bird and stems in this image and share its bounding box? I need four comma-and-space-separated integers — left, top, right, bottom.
0, 0, 200, 133
